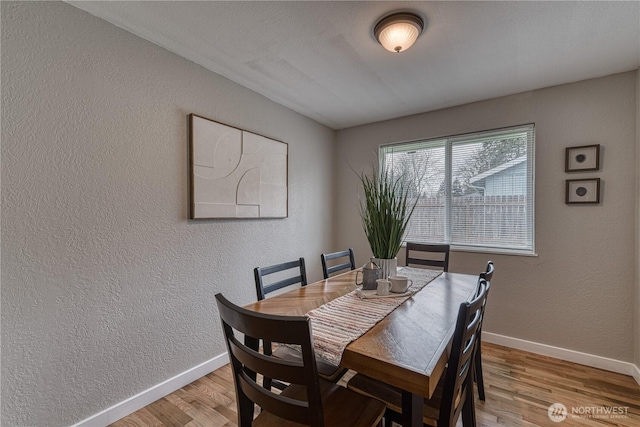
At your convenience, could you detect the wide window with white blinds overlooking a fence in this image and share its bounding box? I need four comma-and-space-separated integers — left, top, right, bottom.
380, 124, 534, 254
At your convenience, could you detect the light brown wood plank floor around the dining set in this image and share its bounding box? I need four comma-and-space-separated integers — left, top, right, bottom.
112, 343, 640, 427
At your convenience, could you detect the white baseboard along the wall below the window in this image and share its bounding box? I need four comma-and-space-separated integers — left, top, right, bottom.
482, 331, 640, 385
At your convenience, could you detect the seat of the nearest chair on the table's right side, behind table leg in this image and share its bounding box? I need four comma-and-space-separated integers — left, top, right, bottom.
347, 374, 445, 426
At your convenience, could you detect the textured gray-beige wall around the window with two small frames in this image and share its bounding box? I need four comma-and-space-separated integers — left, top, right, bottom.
336, 72, 638, 362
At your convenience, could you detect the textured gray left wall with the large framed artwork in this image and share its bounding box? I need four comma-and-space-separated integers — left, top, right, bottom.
1, 2, 335, 427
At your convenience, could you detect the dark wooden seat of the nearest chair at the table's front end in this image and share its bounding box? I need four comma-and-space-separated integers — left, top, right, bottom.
253, 379, 385, 427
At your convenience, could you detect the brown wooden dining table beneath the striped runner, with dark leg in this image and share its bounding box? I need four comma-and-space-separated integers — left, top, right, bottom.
245, 267, 478, 426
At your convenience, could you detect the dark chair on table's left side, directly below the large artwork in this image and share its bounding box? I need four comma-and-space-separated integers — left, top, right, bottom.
253, 258, 347, 390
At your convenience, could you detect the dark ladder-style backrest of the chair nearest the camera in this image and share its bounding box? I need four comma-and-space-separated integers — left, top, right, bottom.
216, 294, 324, 427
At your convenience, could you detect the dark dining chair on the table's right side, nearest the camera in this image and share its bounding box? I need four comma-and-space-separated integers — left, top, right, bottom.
347, 279, 486, 427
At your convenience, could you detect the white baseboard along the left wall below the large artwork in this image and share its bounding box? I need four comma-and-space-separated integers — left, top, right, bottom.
71, 352, 229, 427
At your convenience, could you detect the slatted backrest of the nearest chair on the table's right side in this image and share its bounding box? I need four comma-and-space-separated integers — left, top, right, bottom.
438, 279, 487, 426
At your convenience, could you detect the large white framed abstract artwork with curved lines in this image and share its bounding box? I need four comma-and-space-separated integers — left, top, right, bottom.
189, 114, 288, 219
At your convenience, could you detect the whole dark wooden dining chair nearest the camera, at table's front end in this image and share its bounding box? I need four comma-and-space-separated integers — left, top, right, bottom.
216, 294, 385, 427
